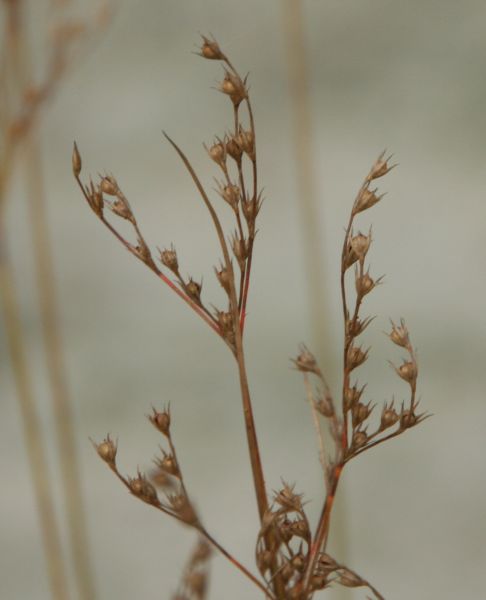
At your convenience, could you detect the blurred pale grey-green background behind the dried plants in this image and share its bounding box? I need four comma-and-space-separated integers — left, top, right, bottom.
0, 0, 486, 600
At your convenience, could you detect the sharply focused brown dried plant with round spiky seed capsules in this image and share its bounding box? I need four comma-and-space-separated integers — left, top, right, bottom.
73, 36, 426, 600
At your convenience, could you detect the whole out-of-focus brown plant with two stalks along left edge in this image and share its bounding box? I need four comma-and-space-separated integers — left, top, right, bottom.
0, 0, 106, 600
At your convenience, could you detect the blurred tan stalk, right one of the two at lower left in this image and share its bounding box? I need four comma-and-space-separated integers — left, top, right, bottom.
26, 137, 96, 600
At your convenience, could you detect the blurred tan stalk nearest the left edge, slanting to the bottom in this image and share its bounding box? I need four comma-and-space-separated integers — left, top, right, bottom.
0, 230, 69, 600
